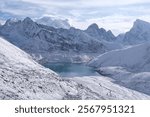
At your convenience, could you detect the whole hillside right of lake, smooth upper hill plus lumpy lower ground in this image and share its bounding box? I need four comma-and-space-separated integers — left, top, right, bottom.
89, 42, 150, 95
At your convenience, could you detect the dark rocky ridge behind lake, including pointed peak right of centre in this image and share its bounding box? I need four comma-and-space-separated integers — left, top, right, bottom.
0, 17, 115, 63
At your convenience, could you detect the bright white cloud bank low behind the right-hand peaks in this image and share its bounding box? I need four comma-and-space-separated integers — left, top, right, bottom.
70, 15, 150, 35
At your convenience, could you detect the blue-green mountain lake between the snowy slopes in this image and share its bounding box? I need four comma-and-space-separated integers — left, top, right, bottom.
44, 63, 98, 77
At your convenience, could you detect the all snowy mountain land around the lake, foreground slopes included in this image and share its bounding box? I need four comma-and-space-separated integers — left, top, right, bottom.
0, 17, 150, 99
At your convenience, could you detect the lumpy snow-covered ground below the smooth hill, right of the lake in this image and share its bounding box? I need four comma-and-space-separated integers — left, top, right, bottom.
97, 67, 150, 95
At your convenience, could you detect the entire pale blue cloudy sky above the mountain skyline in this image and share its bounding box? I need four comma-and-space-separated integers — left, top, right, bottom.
0, 0, 150, 35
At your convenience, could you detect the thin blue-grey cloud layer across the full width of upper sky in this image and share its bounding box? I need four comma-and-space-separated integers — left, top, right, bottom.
0, 0, 150, 20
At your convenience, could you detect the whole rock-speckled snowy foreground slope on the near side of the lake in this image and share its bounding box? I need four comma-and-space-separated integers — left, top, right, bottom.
0, 38, 150, 99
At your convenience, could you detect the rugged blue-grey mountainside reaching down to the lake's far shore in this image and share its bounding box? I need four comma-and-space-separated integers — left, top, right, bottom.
0, 18, 120, 62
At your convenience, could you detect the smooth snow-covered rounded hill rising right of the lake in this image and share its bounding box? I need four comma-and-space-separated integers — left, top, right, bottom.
89, 42, 150, 72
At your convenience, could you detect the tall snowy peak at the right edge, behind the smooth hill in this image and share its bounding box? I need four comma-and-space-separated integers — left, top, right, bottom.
122, 19, 150, 45
